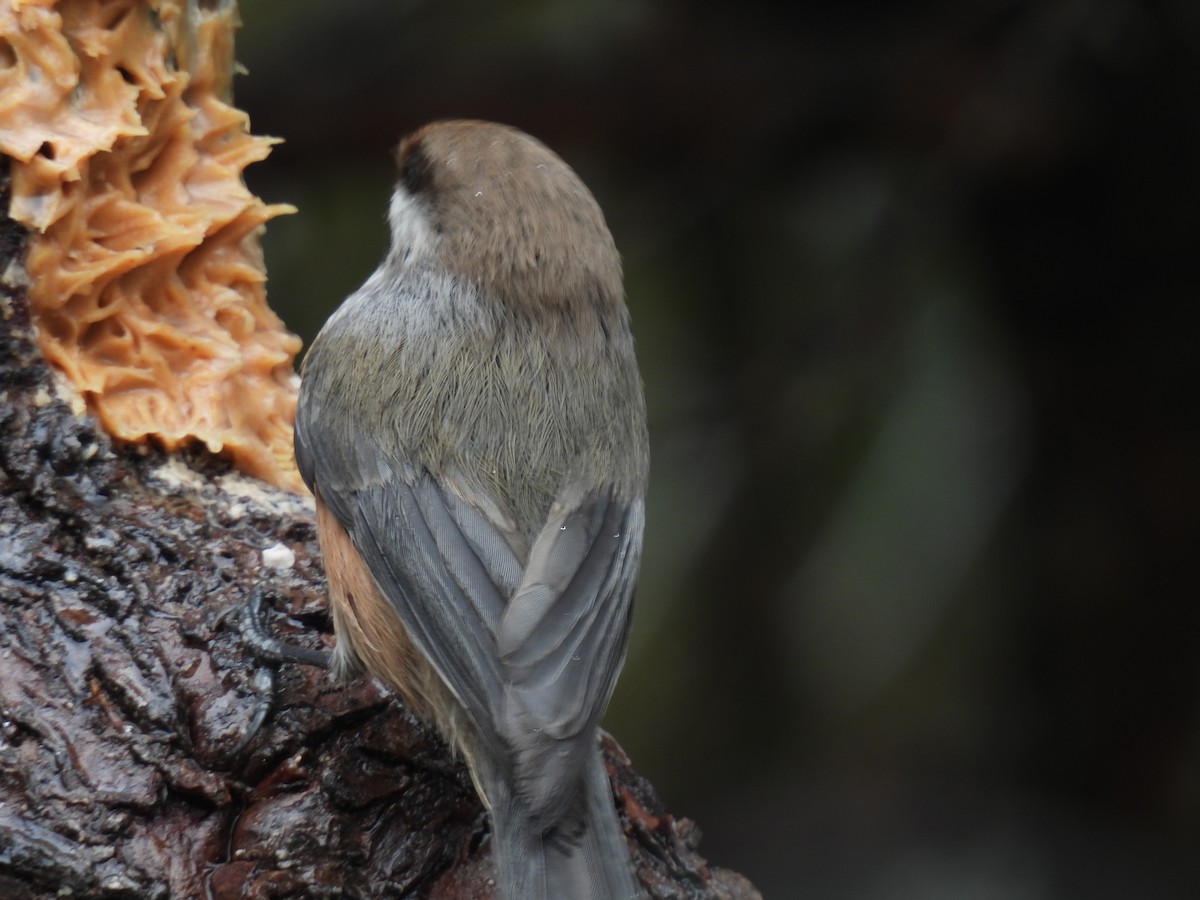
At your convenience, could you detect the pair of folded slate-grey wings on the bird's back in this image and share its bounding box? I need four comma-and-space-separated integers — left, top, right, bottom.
296, 404, 643, 787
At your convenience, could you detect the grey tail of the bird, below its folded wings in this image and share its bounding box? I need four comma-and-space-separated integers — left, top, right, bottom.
487, 746, 642, 900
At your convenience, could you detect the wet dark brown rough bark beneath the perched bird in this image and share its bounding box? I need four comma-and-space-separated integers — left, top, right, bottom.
0, 164, 757, 900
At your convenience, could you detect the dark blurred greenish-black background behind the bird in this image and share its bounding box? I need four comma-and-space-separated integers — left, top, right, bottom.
236, 0, 1200, 900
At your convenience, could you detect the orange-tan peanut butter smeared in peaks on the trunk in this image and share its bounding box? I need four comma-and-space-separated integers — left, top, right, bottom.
0, 0, 304, 491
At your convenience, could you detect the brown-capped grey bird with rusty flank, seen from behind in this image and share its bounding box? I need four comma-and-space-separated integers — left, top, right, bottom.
295, 120, 649, 900
